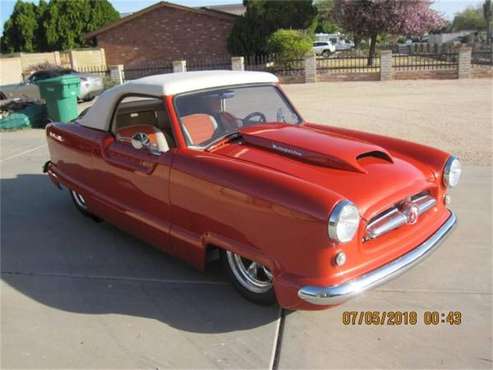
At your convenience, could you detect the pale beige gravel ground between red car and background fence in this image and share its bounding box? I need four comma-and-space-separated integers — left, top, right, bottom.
284, 79, 493, 166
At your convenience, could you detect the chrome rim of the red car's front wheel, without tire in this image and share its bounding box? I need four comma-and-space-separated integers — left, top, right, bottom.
226, 251, 272, 293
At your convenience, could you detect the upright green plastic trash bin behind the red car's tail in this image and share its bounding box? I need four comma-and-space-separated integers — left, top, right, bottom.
36, 75, 80, 122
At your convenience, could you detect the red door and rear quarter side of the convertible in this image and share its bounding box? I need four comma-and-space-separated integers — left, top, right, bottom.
47, 123, 173, 254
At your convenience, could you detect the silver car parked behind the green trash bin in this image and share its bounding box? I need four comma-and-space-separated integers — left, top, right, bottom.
0, 69, 104, 101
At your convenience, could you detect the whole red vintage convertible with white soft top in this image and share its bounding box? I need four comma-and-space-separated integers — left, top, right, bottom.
44, 71, 461, 310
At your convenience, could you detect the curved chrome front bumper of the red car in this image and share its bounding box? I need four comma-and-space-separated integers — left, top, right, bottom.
298, 212, 457, 305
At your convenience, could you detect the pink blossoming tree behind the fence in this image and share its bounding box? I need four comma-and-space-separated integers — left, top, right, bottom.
333, 0, 445, 65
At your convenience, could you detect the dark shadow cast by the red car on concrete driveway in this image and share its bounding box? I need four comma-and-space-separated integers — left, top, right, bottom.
1, 174, 279, 333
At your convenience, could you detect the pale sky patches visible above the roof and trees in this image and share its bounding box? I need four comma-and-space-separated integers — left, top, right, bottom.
0, 0, 482, 33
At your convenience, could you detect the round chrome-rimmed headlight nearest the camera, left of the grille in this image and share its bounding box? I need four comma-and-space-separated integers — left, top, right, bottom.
329, 200, 359, 243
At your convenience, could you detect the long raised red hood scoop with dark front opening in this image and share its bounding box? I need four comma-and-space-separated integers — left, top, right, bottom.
241, 124, 393, 173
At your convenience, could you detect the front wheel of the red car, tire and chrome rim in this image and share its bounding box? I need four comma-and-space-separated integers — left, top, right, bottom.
221, 251, 276, 305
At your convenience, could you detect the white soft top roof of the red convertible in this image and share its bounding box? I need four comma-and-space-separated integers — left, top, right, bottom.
79, 70, 279, 130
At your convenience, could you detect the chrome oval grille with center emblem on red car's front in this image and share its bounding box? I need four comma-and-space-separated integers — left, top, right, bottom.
365, 193, 437, 240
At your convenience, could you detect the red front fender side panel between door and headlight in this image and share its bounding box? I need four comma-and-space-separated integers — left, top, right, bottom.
170, 150, 337, 273
